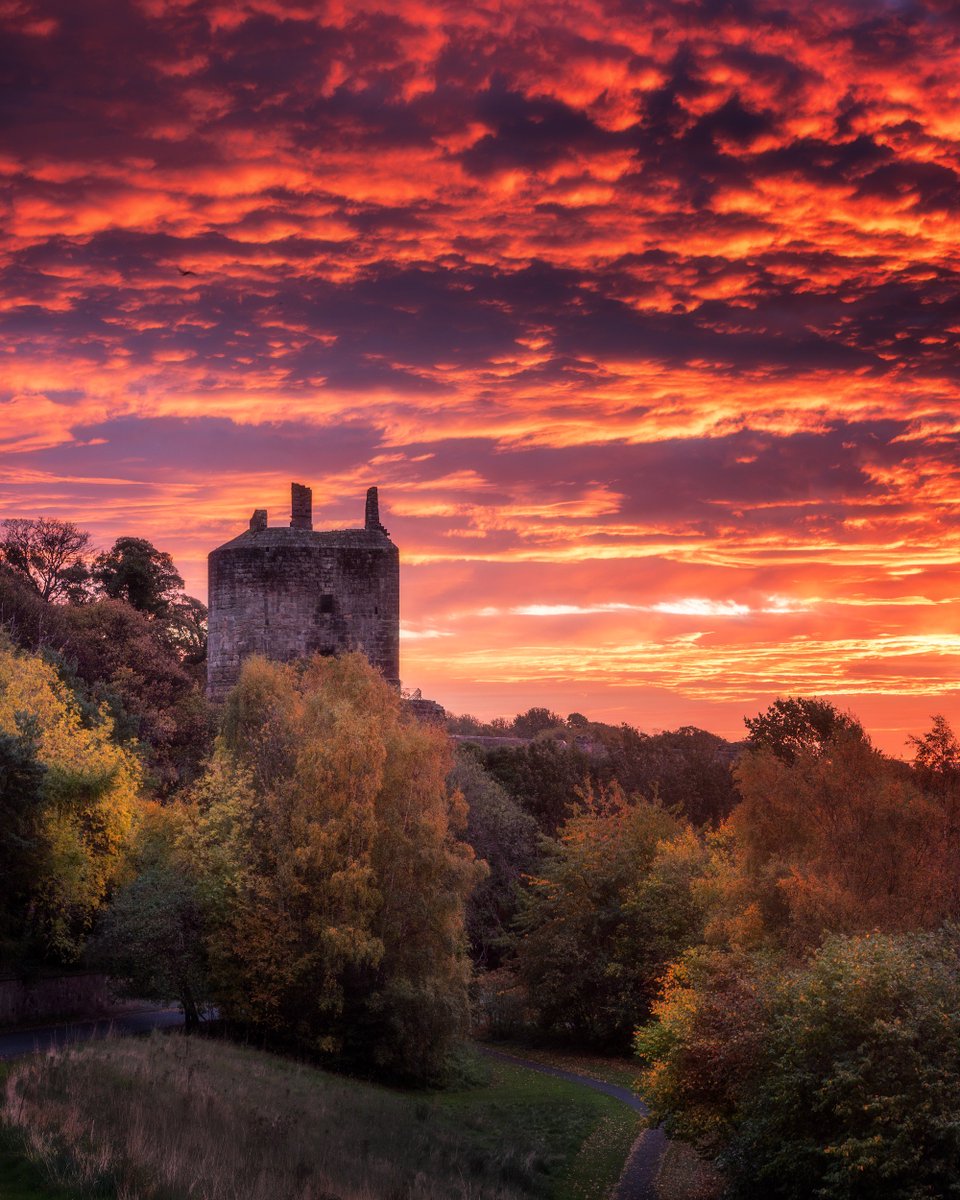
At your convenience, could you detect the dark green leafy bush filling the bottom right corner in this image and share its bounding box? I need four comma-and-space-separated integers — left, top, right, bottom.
725, 930, 960, 1200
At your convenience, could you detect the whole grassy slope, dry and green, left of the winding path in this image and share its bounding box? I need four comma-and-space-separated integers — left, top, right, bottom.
0, 1037, 636, 1200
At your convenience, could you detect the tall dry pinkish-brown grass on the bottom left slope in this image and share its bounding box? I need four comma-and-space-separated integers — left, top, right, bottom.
0, 1037, 529, 1200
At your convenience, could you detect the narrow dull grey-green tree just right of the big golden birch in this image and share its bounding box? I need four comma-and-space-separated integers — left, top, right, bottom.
448, 748, 538, 968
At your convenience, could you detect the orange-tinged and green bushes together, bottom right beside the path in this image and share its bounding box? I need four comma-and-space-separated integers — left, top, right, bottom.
652, 929, 960, 1200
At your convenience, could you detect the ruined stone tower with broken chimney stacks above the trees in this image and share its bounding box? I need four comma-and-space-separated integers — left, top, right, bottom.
206, 484, 400, 701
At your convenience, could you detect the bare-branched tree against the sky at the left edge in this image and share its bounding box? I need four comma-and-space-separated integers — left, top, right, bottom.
0, 517, 90, 601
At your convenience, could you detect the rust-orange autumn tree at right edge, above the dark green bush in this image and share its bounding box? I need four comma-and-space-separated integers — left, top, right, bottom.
731, 730, 960, 950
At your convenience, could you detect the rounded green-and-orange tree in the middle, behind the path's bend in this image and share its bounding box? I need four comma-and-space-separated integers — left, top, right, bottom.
516, 787, 703, 1046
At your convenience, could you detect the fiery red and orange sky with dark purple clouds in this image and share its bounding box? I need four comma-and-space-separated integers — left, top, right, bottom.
0, 0, 960, 754
